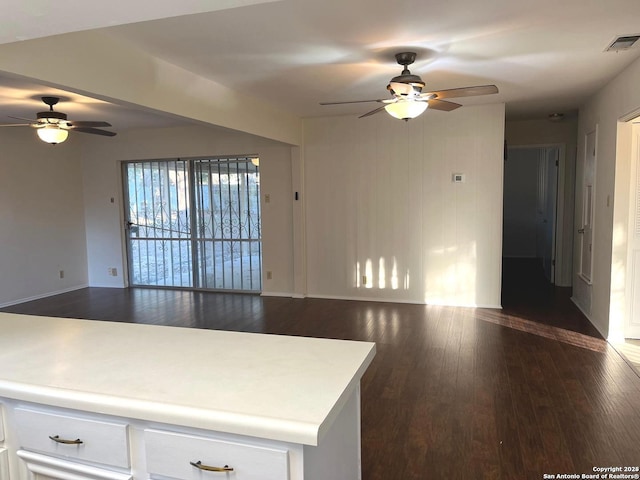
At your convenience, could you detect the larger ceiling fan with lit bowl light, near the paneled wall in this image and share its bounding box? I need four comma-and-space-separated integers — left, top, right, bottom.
320, 52, 498, 121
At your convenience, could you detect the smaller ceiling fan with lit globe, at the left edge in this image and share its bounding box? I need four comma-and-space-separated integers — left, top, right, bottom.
0, 97, 116, 145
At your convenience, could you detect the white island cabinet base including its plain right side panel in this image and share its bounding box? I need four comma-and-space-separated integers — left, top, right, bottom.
0, 400, 360, 480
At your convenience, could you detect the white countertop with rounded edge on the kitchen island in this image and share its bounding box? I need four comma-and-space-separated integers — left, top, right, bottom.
0, 313, 375, 445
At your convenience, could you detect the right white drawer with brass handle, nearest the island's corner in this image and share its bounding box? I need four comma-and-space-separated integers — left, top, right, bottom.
144, 430, 289, 480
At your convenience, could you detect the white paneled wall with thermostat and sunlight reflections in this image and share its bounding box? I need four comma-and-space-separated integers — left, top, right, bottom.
304, 104, 504, 306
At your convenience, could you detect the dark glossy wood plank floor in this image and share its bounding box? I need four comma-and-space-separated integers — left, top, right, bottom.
3, 269, 640, 480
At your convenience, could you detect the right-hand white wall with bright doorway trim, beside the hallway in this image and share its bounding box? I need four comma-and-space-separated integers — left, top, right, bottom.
574, 54, 640, 338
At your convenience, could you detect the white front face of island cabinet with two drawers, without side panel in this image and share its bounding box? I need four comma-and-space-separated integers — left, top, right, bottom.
0, 399, 301, 480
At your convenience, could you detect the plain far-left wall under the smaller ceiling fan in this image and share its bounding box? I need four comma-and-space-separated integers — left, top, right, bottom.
0, 128, 87, 305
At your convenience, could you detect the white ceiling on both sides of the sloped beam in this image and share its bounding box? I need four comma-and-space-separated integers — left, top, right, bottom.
0, 0, 640, 128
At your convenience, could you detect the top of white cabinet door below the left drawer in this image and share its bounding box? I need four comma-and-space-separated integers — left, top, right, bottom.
18, 450, 132, 480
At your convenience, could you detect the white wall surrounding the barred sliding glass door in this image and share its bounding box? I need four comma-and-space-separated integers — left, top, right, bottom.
83, 127, 294, 295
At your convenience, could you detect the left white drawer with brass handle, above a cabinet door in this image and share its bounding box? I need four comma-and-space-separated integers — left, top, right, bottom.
15, 408, 129, 468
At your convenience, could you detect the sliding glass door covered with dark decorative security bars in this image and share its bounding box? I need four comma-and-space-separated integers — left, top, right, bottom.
124, 157, 262, 291
